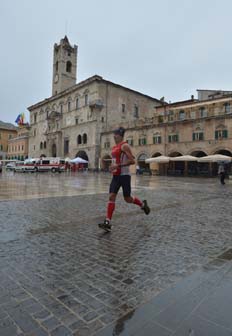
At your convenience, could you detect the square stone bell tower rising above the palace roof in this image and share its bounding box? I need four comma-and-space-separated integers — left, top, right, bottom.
52, 35, 78, 96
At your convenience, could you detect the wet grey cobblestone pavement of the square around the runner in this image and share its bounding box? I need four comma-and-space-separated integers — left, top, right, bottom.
0, 173, 232, 336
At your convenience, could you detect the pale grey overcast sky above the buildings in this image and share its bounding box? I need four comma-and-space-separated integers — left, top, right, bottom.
0, 0, 232, 123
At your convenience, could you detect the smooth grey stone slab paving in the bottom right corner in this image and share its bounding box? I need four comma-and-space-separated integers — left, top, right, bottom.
96, 261, 232, 336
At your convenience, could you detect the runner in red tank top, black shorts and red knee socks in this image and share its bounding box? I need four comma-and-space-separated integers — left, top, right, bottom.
99, 127, 150, 231
